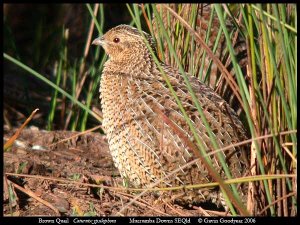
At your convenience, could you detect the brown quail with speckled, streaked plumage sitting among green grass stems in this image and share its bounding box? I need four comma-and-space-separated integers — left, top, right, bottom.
93, 25, 246, 207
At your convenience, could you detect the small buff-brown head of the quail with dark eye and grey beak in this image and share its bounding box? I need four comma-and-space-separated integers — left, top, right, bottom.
92, 25, 155, 62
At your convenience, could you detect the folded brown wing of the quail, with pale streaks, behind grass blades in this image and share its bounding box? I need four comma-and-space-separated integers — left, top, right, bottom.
127, 69, 247, 183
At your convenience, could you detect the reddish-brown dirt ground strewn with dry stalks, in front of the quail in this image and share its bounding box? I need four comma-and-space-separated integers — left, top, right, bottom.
3, 128, 224, 216
